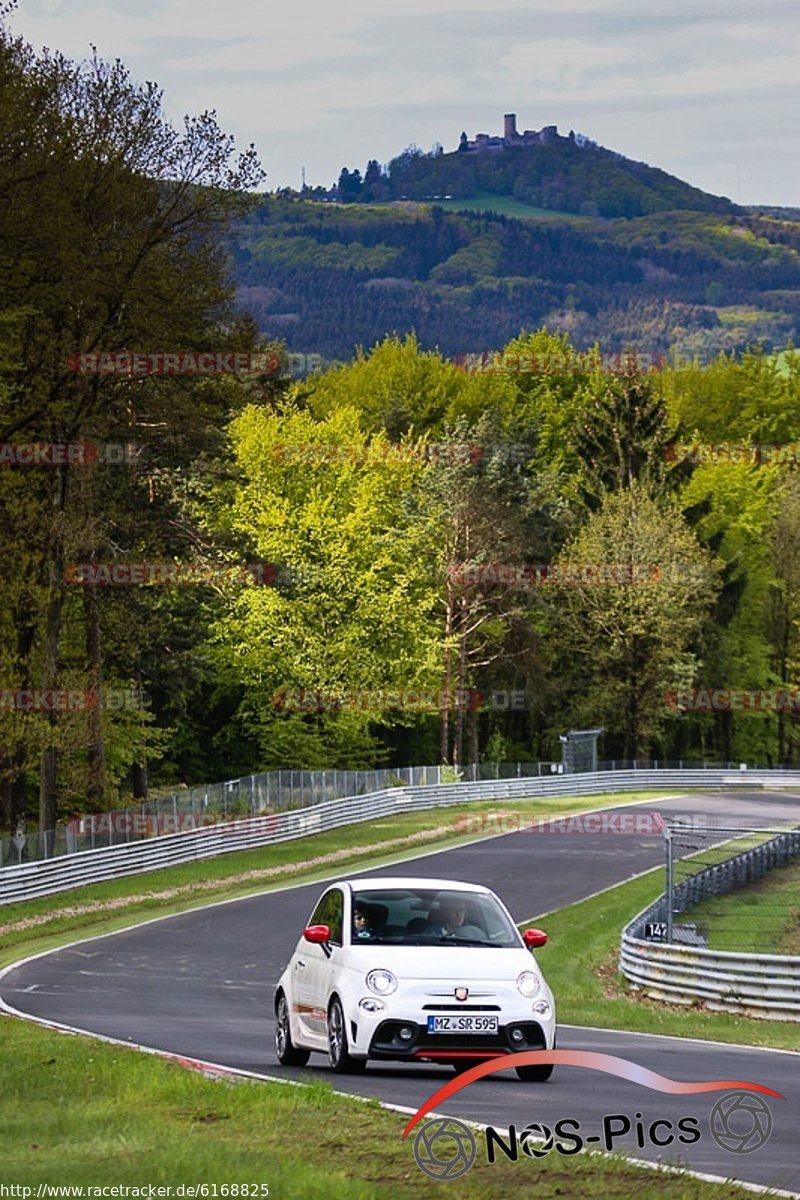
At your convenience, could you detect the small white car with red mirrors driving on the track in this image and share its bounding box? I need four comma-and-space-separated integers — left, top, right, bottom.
275, 877, 555, 1080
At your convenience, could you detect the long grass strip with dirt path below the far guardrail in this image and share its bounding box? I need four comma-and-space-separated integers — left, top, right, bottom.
0, 792, 658, 966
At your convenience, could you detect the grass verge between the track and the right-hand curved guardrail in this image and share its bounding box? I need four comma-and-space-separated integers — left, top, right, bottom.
533, 868, 800, 1050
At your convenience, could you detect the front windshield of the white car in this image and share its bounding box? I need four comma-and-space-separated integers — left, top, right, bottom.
351, 888, 519, 948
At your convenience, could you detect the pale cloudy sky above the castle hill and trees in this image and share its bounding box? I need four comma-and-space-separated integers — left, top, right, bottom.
10, 0, 800, 205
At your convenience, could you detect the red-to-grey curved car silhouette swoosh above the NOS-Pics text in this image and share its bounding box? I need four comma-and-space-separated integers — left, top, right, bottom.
403, 1050, 786, 1139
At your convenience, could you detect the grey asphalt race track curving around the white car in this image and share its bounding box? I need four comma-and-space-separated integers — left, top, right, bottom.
0, 792, 800, 1194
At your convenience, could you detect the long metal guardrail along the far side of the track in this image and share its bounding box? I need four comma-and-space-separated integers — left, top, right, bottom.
0, 768, 800, 905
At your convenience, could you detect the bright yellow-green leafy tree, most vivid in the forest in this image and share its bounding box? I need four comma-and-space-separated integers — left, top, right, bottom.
206, 404, 441, 766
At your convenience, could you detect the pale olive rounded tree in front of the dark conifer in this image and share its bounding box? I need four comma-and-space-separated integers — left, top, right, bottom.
552, 482, 716, 758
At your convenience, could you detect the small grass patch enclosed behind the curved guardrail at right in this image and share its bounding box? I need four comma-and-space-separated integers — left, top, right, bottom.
680, 862, 800, 950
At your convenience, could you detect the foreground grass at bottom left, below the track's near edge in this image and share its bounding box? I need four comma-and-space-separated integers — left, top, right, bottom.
0, 1018, 767, 1200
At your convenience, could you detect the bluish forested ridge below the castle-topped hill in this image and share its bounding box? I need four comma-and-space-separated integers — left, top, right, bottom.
229, 196, 800, 360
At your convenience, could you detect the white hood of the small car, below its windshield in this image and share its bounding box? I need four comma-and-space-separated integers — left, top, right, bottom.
348, 943, 542, 983
